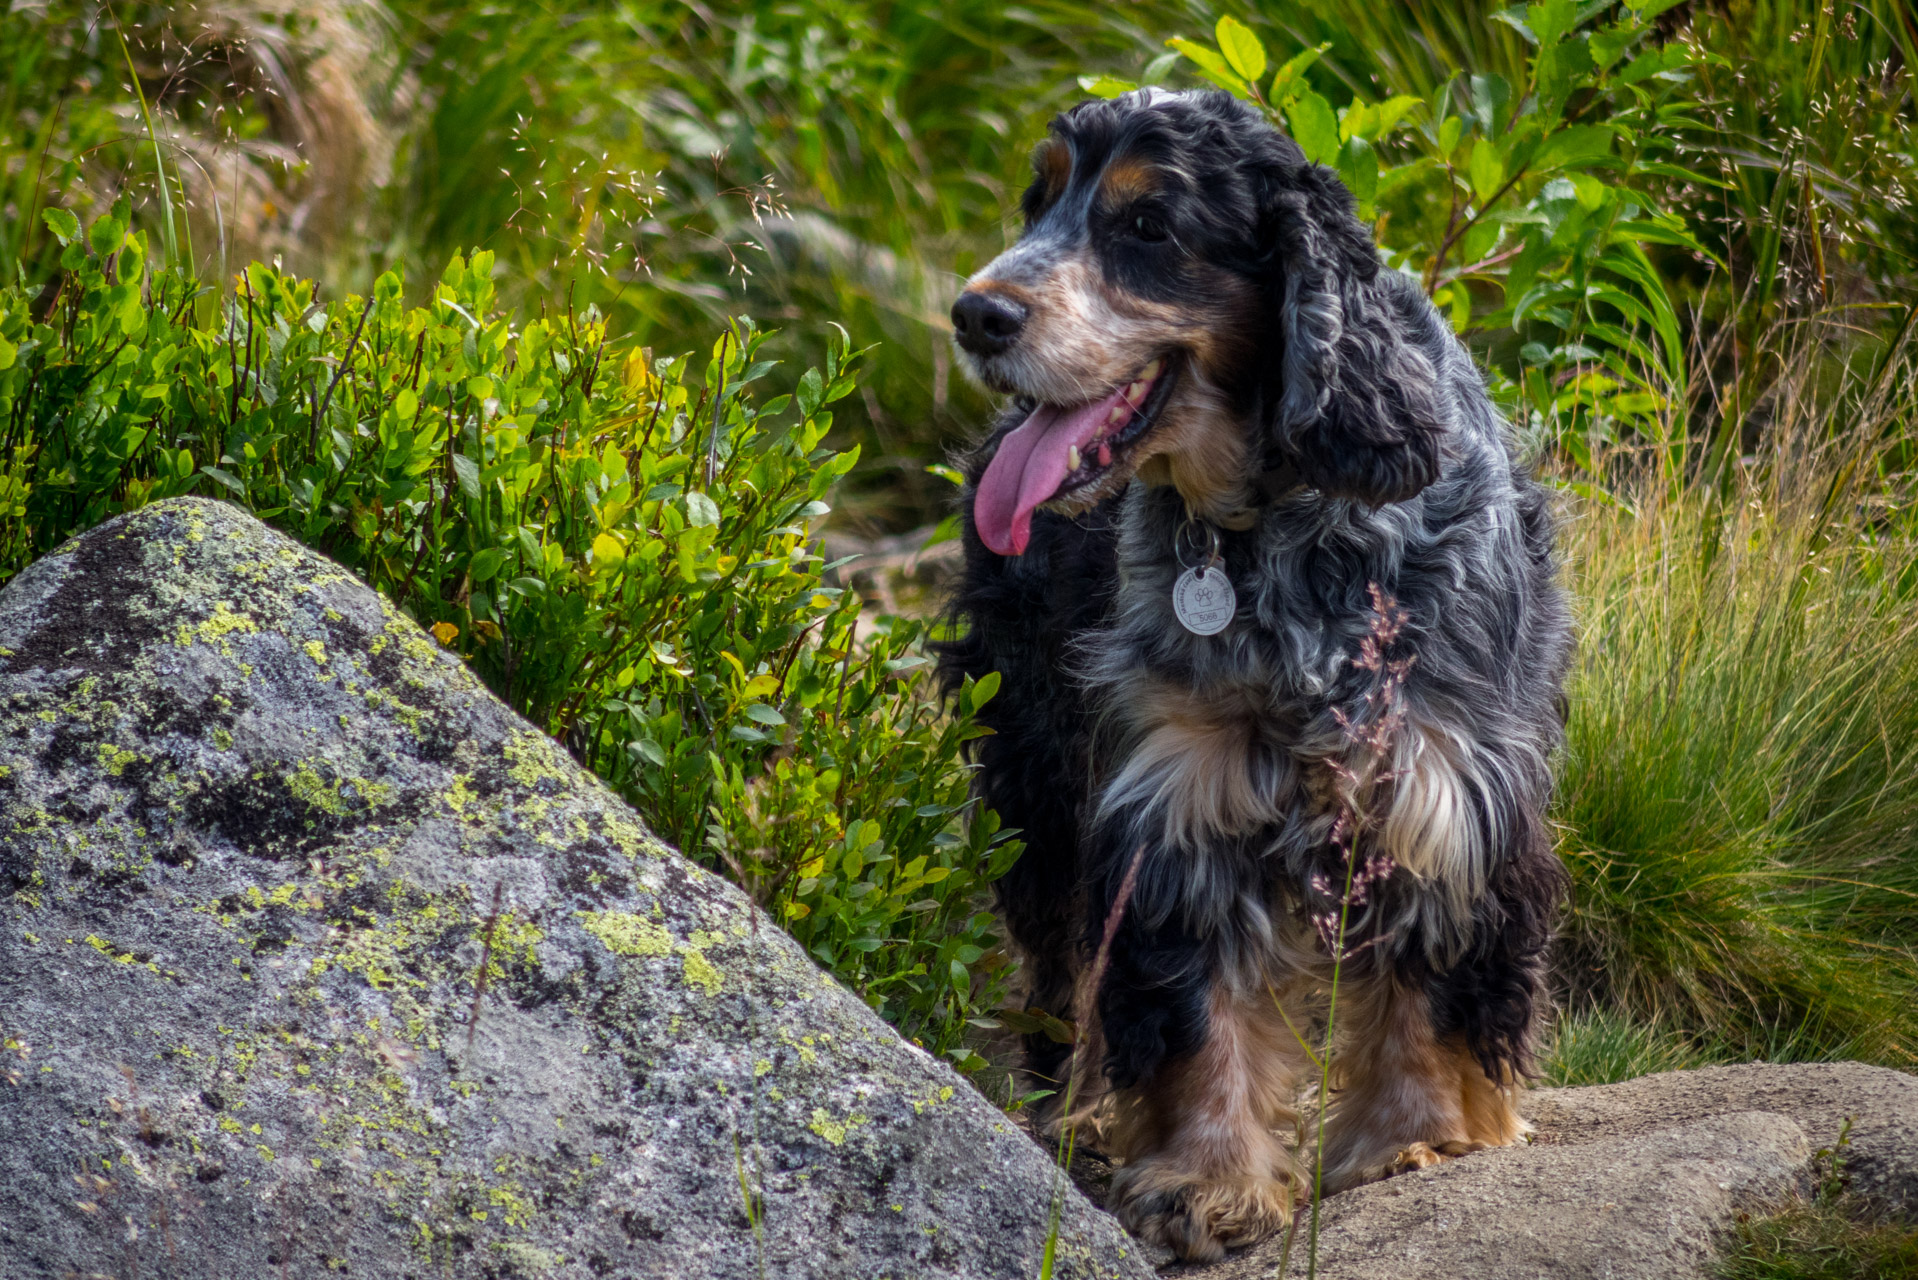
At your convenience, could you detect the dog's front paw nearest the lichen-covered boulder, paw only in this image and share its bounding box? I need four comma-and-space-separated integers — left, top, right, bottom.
1109, 1159, 1298, 1263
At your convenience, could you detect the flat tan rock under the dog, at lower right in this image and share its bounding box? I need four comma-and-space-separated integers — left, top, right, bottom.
1176, 1063, 1918, 1280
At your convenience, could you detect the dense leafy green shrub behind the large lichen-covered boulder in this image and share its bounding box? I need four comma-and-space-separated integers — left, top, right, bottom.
0, 205, 1018, 1065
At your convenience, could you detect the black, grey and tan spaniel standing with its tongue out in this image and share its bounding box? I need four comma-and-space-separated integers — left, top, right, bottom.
938, 88, 1573, 1261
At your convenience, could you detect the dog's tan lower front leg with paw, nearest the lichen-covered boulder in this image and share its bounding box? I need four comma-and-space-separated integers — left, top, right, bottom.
1112, 986, 1304, 1261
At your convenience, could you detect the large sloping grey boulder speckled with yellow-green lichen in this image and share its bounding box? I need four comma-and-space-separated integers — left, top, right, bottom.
0, 501, 1149, 1280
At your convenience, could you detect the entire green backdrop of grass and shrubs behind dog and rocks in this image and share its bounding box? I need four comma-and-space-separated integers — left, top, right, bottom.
0, 0, 1918, 1274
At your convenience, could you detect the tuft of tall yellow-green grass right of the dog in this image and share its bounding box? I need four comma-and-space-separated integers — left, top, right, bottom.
1559, 314, 1918, 1065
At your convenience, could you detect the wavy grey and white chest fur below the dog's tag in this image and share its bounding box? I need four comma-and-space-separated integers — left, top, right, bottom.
1080, 459, 1515, 952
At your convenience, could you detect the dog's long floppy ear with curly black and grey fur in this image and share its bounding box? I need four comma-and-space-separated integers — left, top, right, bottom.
1262, 165, 1444, 505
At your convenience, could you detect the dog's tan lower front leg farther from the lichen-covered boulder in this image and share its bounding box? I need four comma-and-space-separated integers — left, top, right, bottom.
1323, 979, 1525, 1192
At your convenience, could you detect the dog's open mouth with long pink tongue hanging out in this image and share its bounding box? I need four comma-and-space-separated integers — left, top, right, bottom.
972, 357, 1178, 555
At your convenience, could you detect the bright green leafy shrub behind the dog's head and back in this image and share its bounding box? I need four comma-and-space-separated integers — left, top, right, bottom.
1143, 0, 1711, 445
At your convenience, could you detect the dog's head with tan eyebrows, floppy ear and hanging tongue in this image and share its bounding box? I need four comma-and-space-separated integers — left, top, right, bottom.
953, 88, 1444, 555
